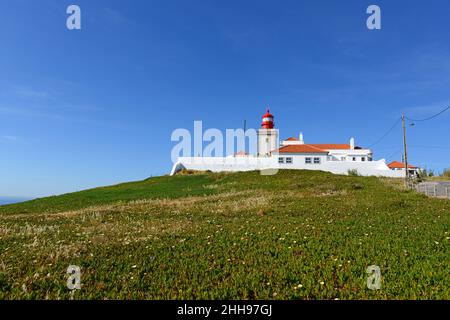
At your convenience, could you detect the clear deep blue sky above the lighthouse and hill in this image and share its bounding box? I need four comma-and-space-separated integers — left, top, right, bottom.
0, 0, 450, 197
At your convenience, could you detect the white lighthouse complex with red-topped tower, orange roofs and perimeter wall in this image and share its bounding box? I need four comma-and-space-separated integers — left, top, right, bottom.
171, 110, 405, 178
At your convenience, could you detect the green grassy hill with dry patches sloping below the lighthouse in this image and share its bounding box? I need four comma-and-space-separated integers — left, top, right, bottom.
0, 170, 450, 299
